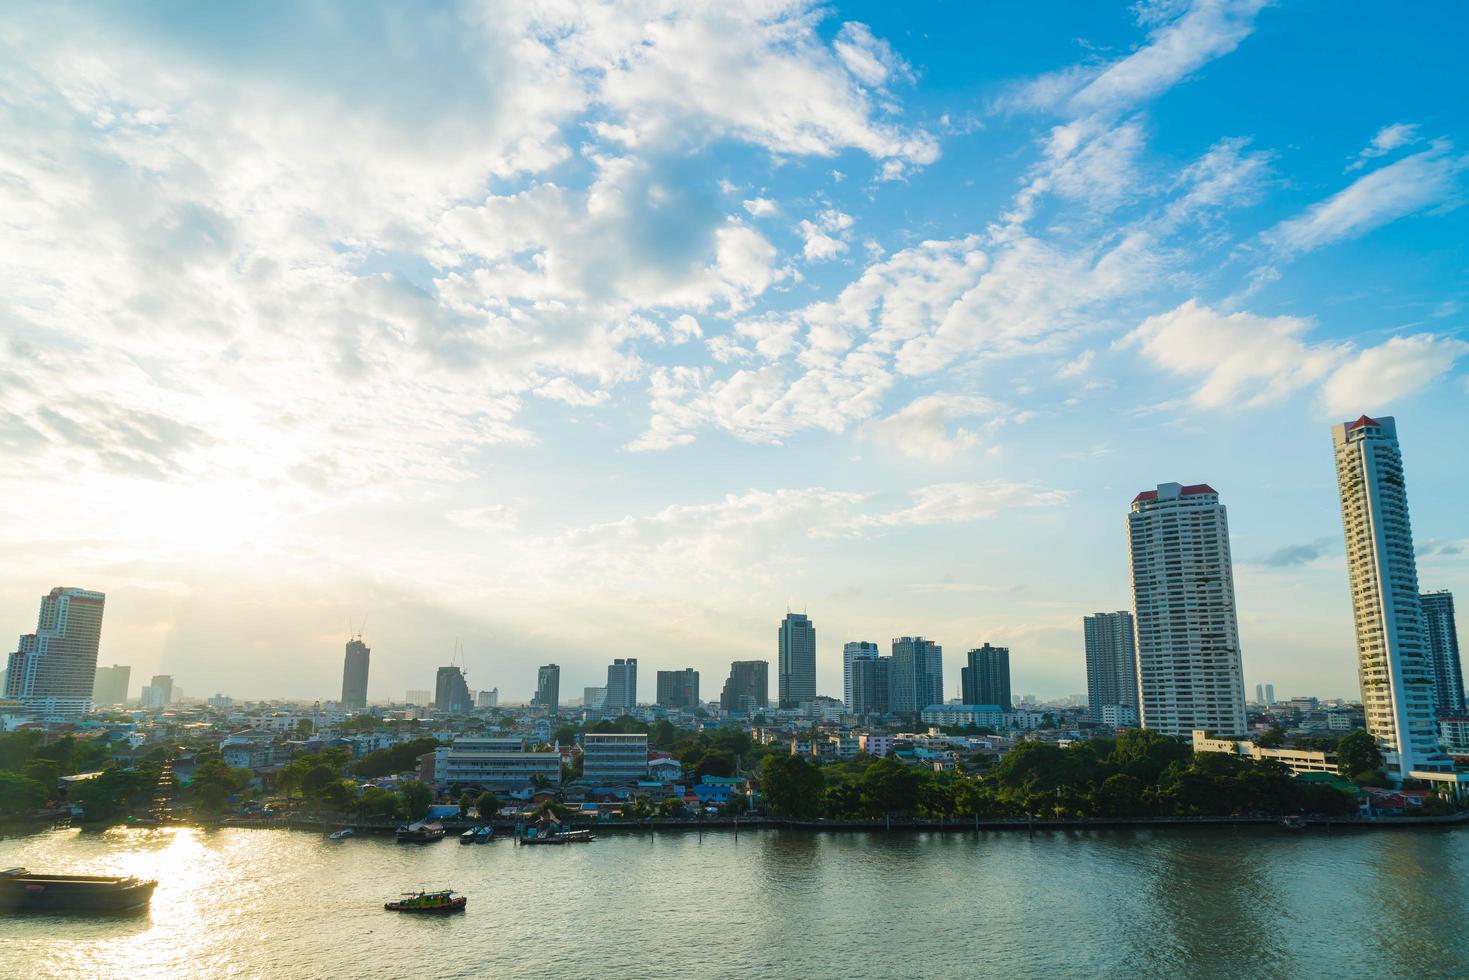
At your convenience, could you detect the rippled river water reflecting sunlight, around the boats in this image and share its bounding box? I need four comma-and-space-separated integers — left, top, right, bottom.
0, 829, 1469, 979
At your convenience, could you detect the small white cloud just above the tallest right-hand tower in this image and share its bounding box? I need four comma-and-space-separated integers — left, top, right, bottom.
1321, 334, 1469, 417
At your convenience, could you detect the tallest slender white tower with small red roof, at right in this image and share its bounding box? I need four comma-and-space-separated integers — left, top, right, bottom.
1331, 416, 1451, 780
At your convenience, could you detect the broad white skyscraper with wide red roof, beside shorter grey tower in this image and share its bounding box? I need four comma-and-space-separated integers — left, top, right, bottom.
1127, 483, 1246, 736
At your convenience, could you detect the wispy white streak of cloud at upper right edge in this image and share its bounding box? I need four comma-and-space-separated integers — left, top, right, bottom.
1265, 143, 1469, 256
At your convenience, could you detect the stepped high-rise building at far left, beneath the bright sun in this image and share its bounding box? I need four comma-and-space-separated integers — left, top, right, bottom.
3, 586, 107, 718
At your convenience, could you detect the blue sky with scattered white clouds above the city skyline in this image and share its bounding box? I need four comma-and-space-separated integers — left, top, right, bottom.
0, 0, 1469, 701
